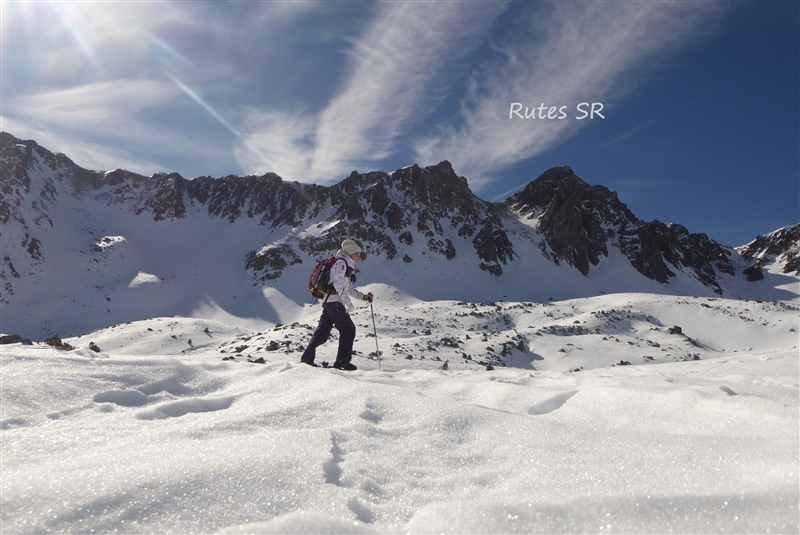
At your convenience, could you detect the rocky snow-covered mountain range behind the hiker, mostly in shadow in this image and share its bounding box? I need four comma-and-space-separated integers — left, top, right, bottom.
0, 132, 798, 336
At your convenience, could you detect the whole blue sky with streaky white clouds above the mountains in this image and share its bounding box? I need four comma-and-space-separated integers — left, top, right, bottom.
0, 0, 800, 244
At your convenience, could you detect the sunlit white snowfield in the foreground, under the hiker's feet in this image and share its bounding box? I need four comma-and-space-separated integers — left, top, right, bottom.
0, 296, 800, 534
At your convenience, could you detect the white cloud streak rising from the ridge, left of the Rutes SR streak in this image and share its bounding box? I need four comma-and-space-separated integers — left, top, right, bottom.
237, 2, 506, 180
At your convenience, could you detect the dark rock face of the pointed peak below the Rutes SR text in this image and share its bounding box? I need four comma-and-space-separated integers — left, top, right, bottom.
506, 166, 734, 293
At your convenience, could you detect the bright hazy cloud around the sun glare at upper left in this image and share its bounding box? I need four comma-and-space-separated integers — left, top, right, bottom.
0, 0, 320, 176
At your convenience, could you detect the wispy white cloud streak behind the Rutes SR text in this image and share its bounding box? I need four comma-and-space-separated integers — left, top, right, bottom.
416, 0, 719, 188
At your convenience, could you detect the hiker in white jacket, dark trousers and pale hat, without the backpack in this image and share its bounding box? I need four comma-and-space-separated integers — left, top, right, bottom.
300, 239, 372, 371
